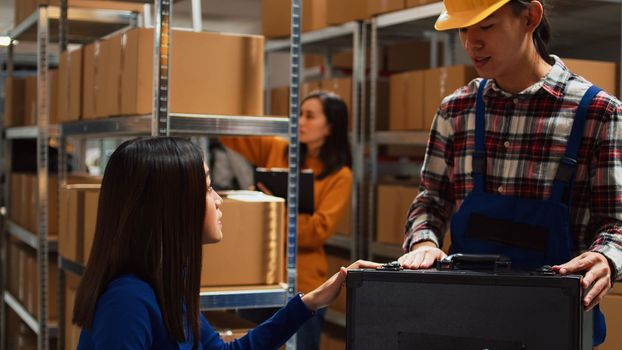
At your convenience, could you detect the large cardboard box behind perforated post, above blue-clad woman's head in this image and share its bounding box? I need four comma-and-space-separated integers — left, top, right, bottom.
119, 29, 264, 115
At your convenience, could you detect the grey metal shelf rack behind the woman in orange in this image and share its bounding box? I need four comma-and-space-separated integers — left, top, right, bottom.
265, 21, 369, 259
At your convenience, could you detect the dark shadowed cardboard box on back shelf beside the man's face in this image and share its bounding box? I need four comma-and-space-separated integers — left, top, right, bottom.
384, 41, 443, 72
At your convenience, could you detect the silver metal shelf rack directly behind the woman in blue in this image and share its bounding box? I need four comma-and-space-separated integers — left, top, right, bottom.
52, 0, 301, 350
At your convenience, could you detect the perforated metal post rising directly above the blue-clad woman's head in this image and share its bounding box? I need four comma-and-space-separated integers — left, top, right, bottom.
151, 0, 173, 136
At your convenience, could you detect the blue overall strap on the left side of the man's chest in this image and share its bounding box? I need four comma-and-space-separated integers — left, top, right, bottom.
472, 79, 488, 192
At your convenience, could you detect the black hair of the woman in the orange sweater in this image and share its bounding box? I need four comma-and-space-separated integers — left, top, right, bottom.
286, 91, 352, 180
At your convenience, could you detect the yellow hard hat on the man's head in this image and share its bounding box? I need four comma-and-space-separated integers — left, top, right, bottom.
434, 0, 510, 30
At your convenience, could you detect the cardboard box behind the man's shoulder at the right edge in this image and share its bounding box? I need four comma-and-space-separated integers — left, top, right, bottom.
562, 58, 619, 96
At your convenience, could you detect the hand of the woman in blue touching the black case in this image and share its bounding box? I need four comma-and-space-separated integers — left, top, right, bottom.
302, 260, 382, 311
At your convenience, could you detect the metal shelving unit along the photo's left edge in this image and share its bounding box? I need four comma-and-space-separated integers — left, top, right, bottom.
0, 1, 137, 350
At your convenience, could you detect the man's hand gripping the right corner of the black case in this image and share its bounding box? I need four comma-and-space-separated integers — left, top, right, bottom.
553, 252, 611, 310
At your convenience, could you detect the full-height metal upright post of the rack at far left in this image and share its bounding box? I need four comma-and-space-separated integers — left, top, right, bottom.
37, 6, 50, 350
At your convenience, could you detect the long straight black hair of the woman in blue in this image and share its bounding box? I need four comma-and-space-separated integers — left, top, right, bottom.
73, 137, 207, 348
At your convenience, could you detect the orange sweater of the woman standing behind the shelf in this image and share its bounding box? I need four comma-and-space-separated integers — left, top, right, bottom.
220, 137, 352, 293
